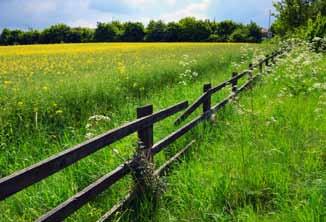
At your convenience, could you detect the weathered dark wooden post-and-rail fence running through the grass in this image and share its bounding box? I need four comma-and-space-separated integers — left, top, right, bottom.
0, 49, 284, 221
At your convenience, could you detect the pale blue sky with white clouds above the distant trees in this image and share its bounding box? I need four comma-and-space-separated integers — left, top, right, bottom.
0, 0, 273, 30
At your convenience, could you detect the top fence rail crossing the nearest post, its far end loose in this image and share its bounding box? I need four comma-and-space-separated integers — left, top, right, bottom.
0, 101, 188, 200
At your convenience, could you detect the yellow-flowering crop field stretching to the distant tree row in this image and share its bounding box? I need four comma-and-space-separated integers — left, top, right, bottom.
0, 43, 262, 143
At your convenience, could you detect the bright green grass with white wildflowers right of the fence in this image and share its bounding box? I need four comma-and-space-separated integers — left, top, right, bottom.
149, 44, 326, 222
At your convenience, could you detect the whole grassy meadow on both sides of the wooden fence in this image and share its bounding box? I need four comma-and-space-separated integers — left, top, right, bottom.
0, 43, 326, 221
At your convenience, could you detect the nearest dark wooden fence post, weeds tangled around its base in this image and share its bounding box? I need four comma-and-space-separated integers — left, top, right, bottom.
137, 105, 154, 162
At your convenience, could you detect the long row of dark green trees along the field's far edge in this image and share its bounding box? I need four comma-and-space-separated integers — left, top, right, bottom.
0, 17, 262, 45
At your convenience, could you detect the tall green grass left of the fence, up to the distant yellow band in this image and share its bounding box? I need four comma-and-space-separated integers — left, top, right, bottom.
0, 44, 265, 221
